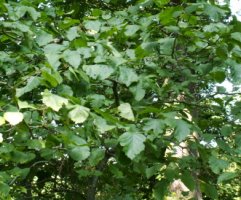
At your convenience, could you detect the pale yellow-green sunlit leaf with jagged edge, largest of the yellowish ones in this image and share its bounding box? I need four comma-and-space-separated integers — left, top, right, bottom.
42, 90, 68, 112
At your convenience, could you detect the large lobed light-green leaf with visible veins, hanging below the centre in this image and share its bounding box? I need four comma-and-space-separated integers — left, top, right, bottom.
118, 132, 146, 160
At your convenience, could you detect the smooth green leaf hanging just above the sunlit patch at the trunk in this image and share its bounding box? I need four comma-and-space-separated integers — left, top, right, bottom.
174, 120, 190, 142
